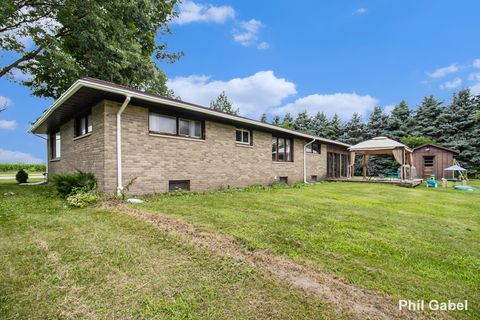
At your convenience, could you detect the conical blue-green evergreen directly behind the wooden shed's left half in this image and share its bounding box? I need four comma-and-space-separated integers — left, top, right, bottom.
413, 96, 443, 140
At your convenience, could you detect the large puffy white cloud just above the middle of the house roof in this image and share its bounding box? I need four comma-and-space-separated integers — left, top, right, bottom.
167, 71, 297, 118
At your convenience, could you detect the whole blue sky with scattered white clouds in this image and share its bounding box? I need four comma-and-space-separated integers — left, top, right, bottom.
0, 0, 480, 162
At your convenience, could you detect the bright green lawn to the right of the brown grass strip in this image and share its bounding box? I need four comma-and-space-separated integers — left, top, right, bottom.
140, 181, 480, 319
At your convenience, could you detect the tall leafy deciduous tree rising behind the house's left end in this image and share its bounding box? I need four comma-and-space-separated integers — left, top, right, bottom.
0, 0, 180, 98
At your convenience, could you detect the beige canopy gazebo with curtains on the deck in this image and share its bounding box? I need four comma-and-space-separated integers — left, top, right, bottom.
348, 137, 413, 180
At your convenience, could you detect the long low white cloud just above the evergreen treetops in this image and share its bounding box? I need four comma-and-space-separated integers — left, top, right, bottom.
272, 93, 378, 120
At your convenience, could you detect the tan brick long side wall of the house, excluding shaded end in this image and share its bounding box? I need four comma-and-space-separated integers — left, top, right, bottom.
105, 102, 326, 194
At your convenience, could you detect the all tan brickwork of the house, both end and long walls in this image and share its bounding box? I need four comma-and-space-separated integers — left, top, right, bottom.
49, 101, 334, 194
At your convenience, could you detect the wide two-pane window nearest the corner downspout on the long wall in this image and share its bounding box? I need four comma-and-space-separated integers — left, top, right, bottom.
148, 112, 203, 139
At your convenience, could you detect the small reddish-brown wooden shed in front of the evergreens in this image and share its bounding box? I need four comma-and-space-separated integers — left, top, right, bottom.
413, 143, 459, 179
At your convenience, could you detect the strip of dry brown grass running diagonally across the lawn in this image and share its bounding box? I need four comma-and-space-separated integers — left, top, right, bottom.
107, 202, 425, 319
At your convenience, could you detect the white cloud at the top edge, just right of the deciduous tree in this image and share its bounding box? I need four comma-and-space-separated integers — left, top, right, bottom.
173, 0, 235, 25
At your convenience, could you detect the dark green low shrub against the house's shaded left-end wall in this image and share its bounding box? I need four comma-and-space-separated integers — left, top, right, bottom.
52, 171, 97, 197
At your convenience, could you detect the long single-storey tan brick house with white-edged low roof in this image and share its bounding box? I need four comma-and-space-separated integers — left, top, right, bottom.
30, 78, 349, 194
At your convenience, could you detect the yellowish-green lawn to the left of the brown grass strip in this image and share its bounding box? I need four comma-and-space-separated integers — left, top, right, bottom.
0, 181, 338, 319
